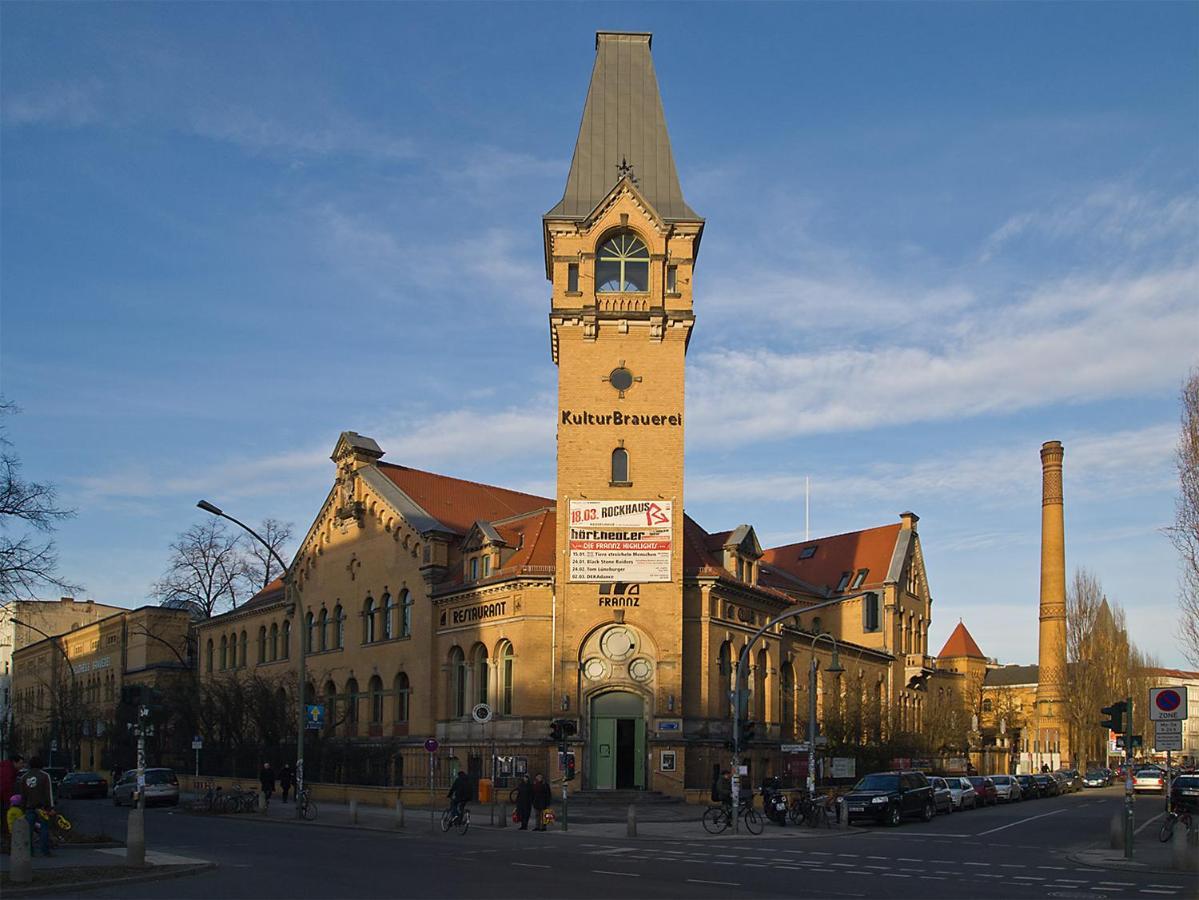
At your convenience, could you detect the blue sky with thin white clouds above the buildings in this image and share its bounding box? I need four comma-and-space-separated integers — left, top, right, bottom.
0, 2, 1199, 666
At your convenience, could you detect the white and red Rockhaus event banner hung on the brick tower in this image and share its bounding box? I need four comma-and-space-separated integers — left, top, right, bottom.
570, 500, 674, 582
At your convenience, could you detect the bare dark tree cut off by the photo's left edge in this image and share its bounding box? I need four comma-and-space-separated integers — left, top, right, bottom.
0, 400, 78, 598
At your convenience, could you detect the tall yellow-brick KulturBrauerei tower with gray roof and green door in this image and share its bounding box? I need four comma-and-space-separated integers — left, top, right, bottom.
543, 32, 704, 790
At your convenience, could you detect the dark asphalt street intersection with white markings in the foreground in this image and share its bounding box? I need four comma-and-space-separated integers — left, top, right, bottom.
51, 789, 1199, 900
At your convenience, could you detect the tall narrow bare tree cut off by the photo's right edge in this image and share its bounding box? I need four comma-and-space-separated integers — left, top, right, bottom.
1169, 369, 1199, 666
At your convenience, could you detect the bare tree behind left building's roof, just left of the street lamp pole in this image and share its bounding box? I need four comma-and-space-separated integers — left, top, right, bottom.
150, 519, 253, 617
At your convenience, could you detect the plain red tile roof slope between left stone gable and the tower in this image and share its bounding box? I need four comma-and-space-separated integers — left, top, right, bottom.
375, 461, 554, 534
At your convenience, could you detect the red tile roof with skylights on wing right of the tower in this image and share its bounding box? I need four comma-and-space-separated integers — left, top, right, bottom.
761, 523, 903, 592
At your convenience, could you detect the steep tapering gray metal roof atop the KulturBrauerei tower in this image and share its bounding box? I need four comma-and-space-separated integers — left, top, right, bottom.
546, 31, 700, 221
